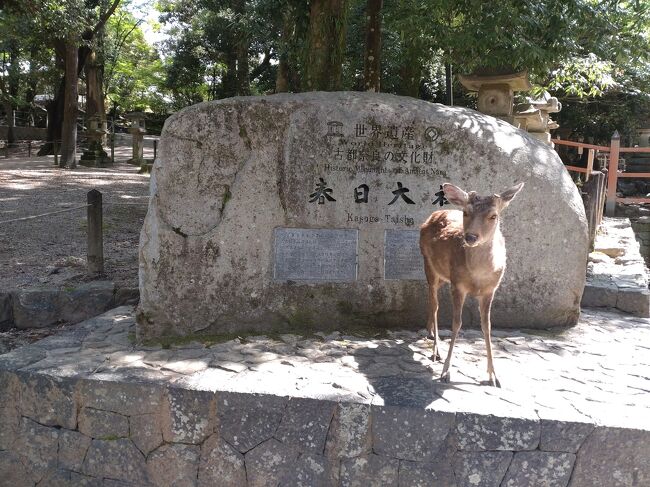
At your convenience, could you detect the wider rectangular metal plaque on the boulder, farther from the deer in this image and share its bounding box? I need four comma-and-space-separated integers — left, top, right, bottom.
273, 228, 359, 281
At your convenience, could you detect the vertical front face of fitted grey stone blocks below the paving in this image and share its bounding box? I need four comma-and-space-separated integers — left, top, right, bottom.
0, 371, 650, 487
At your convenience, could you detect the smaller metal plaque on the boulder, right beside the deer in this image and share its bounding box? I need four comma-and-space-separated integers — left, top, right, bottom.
384, 230, 426, 280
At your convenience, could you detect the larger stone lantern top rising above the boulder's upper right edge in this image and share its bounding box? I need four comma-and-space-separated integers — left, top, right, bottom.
460, 71, 532, 125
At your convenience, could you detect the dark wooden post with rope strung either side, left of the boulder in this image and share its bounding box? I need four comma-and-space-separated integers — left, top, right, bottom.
0, 189, 149, 274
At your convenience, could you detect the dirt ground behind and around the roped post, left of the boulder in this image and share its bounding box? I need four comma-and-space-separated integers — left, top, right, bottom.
0, 146, 153, 292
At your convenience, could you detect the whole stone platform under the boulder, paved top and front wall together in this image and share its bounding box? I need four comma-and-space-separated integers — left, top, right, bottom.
0, 307, 650, 487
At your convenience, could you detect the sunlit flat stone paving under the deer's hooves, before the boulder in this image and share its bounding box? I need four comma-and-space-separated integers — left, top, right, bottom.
5, 307, 650, 429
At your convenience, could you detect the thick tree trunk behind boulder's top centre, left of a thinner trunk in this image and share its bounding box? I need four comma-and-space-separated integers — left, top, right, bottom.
305, 0, 348, 91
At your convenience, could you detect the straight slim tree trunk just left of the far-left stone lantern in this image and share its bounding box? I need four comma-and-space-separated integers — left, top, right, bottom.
60, 39, 79, 167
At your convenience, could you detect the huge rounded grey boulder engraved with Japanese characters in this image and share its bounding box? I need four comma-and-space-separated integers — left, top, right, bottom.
138, 93, 588, 339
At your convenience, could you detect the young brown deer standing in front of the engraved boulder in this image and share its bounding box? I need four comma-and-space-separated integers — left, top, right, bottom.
420, 183, 524, 387
